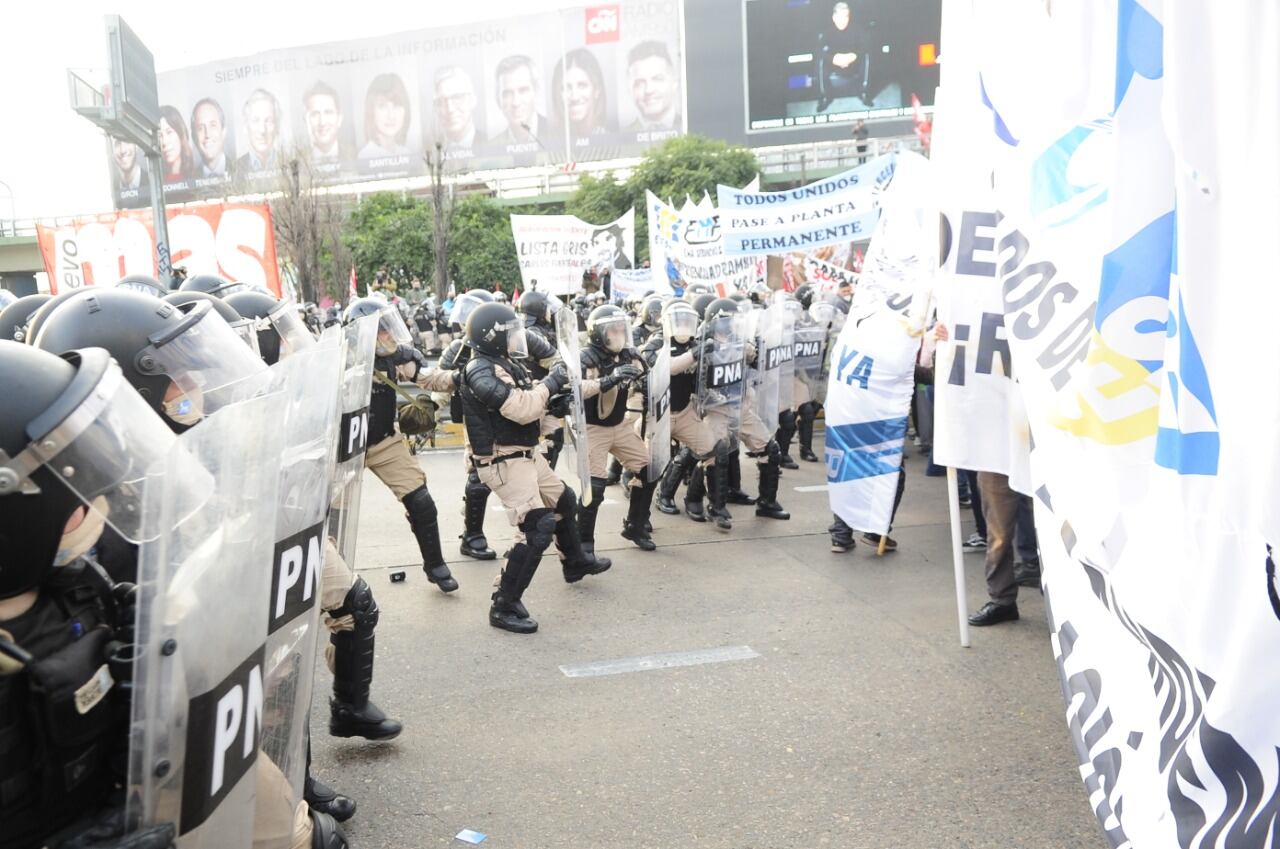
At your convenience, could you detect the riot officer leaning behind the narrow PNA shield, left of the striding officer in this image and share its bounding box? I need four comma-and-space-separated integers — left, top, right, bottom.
343, 298, 458, 593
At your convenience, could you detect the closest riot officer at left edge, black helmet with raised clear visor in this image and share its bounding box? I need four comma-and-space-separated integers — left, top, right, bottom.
0, 342, 183, 849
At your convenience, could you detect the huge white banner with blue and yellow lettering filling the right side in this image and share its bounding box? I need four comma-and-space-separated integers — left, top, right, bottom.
934, 0, 1280, 849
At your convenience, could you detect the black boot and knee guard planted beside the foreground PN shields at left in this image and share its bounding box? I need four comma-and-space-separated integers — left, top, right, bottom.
329, 578, 403, 740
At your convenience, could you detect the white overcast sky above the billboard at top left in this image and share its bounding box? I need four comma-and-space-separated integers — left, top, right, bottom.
0, 0, 570, 219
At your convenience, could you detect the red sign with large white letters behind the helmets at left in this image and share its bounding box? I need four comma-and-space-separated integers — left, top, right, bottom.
36, 204, 280, 296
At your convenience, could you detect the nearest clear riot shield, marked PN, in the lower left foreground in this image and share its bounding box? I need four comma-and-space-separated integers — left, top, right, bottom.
128, 393, 294, 849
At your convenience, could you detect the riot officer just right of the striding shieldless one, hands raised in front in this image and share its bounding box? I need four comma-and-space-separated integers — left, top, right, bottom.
579, 303, 657, 553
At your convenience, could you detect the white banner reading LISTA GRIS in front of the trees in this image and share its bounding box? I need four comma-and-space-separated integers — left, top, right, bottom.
511, 209, 636, 295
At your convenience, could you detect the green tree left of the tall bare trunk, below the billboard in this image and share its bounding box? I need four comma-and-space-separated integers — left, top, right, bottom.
343, 192, 433, 292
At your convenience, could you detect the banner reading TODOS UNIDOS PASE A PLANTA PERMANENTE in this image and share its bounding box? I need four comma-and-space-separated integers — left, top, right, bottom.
716, 154, 897, 256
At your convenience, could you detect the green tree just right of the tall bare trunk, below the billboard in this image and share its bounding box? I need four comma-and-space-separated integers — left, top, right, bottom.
449, 195, 520, 295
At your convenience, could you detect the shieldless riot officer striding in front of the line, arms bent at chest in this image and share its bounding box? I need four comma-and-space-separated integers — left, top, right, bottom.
458, 303, 612, 634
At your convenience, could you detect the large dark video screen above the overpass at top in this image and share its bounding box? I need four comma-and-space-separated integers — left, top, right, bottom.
742, 0, 942, 133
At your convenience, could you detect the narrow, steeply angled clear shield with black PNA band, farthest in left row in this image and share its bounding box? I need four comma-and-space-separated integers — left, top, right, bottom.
327, 315, 379, 569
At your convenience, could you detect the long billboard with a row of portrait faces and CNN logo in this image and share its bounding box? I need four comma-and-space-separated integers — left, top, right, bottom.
110, 0, 685, 207
